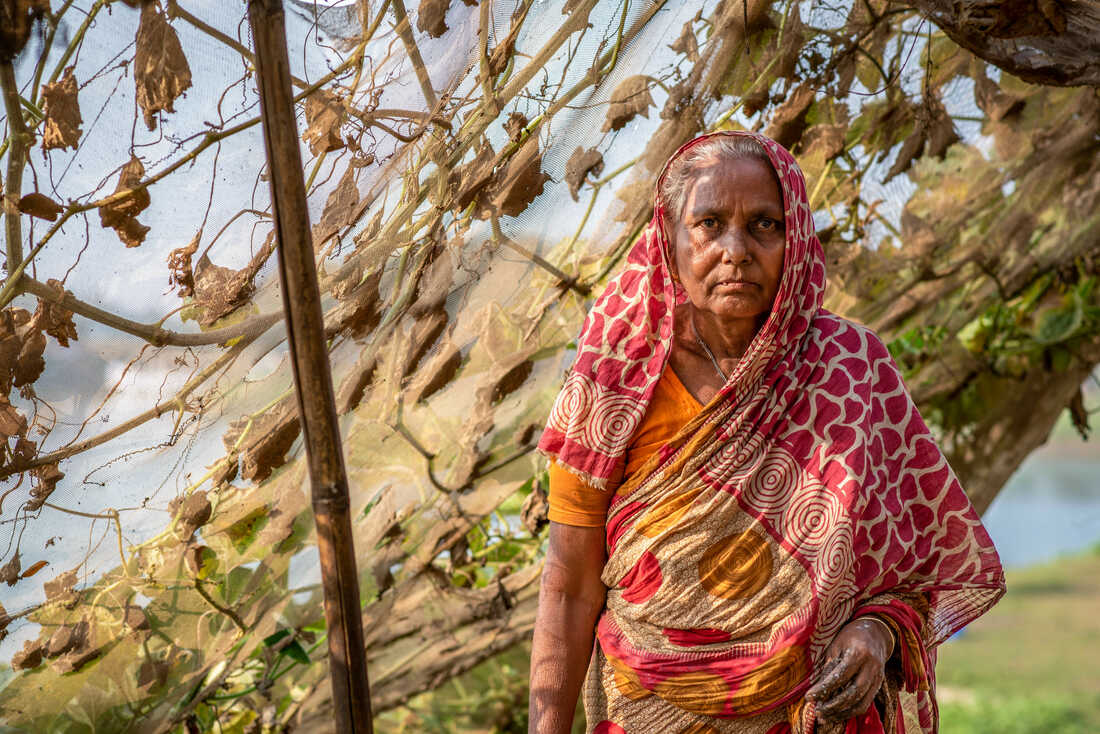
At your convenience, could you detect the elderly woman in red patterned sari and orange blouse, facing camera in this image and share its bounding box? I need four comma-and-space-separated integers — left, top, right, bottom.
530, 132, 1004, 734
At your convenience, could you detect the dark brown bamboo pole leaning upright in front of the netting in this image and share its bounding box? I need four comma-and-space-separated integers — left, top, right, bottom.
249, 0, 373, 734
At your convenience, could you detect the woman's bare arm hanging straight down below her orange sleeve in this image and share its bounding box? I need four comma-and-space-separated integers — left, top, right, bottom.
528, 522, 607, 734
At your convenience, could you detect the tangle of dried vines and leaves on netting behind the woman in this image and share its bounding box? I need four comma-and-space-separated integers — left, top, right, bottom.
0, 0, 1100, 732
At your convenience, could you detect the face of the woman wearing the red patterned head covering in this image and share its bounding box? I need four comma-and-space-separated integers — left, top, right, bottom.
672, 157, 787, 321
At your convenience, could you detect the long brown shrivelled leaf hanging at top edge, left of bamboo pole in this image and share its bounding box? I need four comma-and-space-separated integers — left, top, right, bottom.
134, 2, 191, 130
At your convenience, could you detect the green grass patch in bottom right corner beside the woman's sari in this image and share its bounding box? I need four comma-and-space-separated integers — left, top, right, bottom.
936, 551, 1100, 734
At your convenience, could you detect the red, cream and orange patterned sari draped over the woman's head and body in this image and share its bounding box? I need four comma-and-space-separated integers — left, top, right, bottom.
539, 132, 1004, 734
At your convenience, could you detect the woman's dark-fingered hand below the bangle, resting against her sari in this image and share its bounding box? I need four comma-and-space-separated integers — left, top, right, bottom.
806, 617, 894, 724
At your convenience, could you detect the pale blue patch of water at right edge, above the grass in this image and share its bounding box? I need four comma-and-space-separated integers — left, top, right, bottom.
982, 447, 1100, 568
